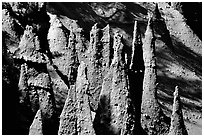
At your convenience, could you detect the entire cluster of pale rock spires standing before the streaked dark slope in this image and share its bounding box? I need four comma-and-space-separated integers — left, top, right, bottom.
2, 1, 187, 135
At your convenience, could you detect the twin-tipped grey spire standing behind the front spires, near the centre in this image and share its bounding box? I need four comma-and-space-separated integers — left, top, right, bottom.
87, 24, 111, 111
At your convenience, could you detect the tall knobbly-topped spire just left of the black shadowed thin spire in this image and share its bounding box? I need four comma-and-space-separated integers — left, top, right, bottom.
110, 33, 135, 135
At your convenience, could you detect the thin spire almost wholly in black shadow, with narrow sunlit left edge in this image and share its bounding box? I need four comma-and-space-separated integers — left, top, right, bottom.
128, 21, 145, 134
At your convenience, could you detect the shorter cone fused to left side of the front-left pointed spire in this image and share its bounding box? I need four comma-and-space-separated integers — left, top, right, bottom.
58, 85, 77, 135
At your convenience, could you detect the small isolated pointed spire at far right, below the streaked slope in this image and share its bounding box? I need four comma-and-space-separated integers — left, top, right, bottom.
169, 86, 188, 135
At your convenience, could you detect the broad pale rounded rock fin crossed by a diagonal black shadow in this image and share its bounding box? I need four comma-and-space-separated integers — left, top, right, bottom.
47, 14, 78, 110
